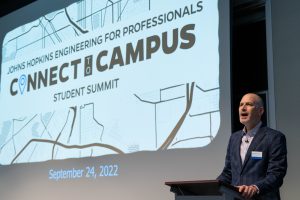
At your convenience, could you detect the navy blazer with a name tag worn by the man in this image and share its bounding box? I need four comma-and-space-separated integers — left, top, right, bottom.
217, 126, 287, 200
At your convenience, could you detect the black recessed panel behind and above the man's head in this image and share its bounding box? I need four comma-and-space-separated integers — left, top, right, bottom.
231, 19, 268, 131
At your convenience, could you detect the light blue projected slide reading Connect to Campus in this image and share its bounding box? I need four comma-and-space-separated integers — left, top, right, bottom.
0, 0, 220, 165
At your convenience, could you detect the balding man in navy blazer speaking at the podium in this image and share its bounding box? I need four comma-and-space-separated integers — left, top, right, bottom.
217, 93, 287, 200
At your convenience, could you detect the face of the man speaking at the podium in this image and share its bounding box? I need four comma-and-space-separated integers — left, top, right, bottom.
239, 94, 264, 130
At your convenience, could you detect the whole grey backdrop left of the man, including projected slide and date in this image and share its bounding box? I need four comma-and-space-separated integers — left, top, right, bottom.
0, 0, 231, 200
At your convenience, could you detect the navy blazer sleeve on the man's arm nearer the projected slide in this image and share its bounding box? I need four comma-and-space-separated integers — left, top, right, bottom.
217, 137, 232, 184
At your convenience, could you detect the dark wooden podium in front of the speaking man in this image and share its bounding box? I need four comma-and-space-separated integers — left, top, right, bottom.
165, 180, 244, 200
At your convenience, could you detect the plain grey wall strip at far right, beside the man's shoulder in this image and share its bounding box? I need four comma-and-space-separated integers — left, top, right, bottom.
268, 0, 300, 200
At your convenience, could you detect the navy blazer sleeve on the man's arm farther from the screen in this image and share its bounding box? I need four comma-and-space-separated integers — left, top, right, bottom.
255, 132, 287, 194
